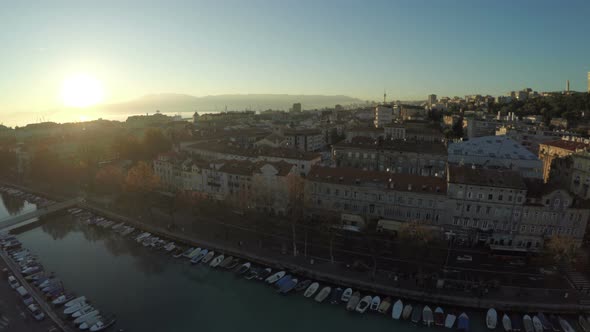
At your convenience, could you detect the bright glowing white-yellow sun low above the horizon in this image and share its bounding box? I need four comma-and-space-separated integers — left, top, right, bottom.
61, 74, 104, 108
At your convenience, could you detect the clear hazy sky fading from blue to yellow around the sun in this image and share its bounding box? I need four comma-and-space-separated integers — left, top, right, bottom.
0, 0, 590, 113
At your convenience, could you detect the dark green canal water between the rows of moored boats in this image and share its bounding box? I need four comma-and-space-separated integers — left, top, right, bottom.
0, 196, 485, 332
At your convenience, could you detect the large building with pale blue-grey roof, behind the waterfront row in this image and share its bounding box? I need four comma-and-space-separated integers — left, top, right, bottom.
448, 136, 543, 179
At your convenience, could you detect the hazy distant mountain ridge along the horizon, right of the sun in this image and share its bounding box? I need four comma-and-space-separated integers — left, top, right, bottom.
93, 93, 365, 114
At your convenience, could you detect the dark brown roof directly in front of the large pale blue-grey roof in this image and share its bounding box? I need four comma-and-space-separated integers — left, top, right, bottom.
449, 165, 526, 189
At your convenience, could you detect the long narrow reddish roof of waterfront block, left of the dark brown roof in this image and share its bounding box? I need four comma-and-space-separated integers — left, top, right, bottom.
307, 166, 447, 195
